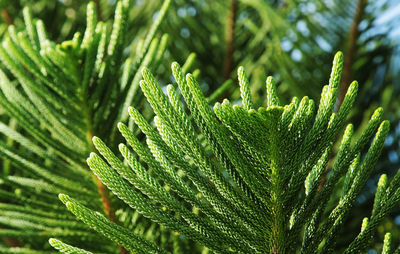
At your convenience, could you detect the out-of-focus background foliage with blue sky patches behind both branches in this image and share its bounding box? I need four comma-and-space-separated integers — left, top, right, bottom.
0, 0, 400, 253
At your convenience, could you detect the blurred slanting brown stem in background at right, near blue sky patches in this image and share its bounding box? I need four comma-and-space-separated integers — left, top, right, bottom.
337, 0, 366, 108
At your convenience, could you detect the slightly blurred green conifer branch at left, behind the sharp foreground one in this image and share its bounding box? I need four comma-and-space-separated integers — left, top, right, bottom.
0, 0, 170, 253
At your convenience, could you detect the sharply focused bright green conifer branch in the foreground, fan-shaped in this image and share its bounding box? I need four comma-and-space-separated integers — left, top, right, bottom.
50, 53, 400, 253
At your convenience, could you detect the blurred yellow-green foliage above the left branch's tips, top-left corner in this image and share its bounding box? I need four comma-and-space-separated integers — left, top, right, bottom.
0, 0, 166, 42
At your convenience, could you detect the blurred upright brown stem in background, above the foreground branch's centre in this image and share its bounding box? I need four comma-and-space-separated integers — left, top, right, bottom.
223, 0, 238, 80
